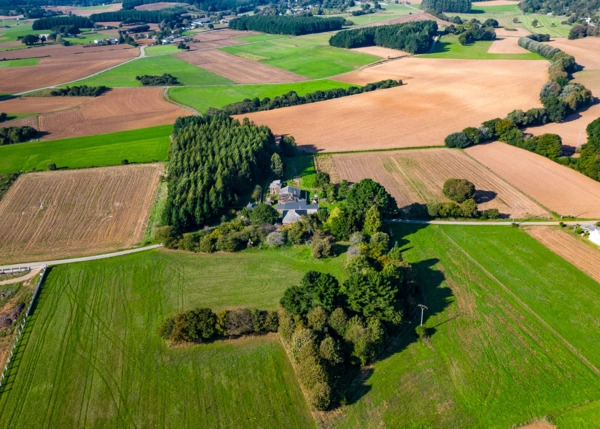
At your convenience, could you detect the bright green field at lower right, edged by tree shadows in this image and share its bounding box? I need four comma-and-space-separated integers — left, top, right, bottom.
328, 226, 600, 428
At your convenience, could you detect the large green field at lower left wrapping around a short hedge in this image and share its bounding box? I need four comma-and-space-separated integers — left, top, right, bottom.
0, 248, 345, 428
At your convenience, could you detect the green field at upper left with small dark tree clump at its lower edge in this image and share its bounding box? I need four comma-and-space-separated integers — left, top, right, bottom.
71, 55, 232, 87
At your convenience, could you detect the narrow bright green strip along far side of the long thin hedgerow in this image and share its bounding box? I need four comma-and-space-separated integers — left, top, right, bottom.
169, 80, 352, 112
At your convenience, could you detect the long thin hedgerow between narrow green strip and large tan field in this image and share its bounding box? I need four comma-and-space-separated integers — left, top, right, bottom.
207, 79, 402, 115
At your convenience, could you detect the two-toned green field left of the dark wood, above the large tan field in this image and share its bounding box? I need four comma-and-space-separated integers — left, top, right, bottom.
221, 33, 380, 79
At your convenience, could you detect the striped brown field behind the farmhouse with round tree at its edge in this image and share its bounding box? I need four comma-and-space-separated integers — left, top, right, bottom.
324, 149, 549, 218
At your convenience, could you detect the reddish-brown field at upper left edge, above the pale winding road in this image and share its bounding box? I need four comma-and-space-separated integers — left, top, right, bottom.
0, 45, 138, 94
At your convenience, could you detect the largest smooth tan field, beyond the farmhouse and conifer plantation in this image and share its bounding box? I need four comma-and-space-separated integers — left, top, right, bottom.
241, 57, 548, 152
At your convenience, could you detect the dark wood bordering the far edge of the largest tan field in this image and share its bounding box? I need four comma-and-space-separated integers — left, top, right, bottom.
329, 21, 438, 54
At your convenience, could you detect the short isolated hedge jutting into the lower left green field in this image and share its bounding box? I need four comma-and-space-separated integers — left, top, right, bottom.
158, 308, 279, 343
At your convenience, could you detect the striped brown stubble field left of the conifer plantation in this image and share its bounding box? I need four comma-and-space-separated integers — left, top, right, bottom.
0, 164, 163, 264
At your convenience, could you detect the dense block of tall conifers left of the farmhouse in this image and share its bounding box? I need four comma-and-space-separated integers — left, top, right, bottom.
163, 115, 276, 231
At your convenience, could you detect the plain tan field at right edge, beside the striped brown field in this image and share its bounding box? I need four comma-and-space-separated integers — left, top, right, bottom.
466, 142, 600, 218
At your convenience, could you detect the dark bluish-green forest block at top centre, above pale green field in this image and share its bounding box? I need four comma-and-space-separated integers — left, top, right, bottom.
229, 15, 346, 36
